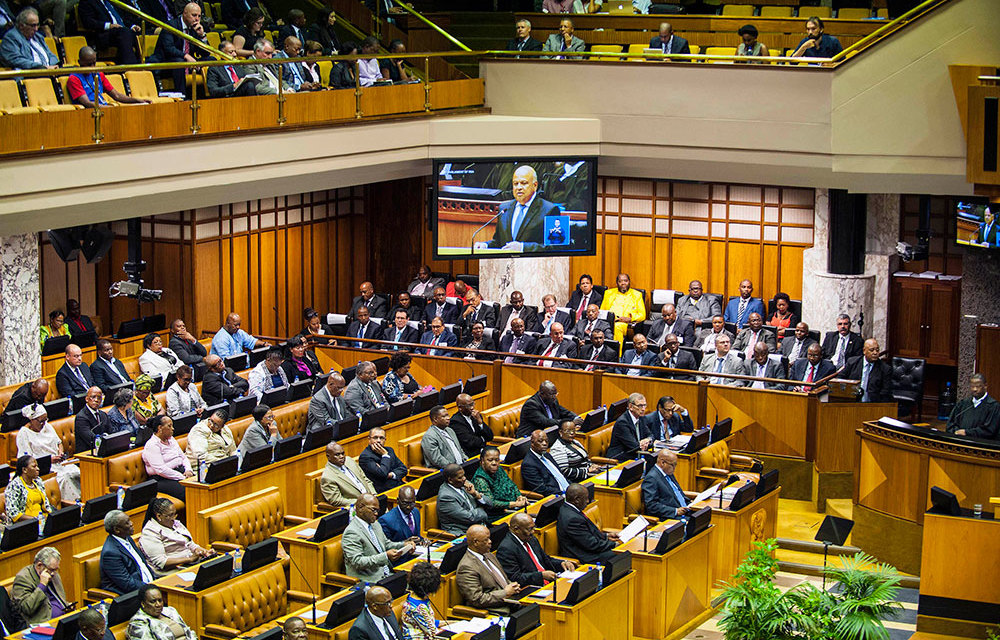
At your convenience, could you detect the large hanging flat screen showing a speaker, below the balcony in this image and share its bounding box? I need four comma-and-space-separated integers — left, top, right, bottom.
431, 157, 597, 260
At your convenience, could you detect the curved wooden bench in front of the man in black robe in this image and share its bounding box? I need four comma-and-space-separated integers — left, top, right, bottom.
851, 423, 1000, 575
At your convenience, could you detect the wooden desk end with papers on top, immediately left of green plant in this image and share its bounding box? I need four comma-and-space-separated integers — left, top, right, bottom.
615, 524, 718, 638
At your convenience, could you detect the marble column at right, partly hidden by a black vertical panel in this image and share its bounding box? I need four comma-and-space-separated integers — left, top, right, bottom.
802, 189, 899, 347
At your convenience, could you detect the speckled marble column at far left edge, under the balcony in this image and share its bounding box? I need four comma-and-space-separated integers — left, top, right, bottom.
0, 233, 42, 386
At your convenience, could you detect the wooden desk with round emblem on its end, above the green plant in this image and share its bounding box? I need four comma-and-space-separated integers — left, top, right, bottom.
698, 484, 781, 586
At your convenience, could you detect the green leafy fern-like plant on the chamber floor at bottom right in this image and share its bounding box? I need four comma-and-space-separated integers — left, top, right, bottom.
719, 540, 901, 640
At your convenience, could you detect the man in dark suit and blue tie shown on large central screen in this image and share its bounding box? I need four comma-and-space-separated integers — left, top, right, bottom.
475, 165, 560, 253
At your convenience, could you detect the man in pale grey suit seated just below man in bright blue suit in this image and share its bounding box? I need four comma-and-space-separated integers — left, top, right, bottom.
340, 493, 414, 582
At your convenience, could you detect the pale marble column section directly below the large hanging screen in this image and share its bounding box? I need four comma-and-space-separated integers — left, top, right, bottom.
479, 257, 570, 307
